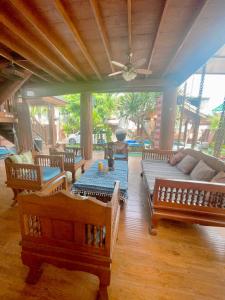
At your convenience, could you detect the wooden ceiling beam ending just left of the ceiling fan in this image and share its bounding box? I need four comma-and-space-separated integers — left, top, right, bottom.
89, 0, 115, 72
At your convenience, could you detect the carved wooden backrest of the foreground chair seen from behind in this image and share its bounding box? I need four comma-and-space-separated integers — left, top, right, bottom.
18, 185, 119, 256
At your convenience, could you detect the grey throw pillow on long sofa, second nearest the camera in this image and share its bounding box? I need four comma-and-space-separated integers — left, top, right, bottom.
190, 160, 216, 181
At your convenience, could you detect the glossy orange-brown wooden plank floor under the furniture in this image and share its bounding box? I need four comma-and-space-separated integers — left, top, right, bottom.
0, 157, 225, 300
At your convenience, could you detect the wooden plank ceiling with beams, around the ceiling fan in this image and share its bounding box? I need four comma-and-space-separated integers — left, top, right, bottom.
0, 0, 225, 96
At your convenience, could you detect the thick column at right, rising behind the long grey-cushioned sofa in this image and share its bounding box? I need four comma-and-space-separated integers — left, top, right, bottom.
159, 87, 177, 150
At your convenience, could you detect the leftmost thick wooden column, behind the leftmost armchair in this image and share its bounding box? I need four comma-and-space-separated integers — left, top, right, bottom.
15, 98, 33, 151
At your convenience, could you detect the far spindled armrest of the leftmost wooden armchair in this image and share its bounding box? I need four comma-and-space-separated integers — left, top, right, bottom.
34, 154, 64, 171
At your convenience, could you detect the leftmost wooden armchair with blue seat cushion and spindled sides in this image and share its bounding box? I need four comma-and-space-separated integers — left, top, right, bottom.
5, 155, 65, 206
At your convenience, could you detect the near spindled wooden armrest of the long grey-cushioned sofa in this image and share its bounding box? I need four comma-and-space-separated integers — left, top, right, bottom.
153, 178, 225, 212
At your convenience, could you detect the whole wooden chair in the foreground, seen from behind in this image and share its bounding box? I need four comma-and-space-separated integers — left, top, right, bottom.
18, 182, 120, 300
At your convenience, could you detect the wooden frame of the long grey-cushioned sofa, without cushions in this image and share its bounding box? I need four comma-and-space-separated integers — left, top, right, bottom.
142, 149, 225, 234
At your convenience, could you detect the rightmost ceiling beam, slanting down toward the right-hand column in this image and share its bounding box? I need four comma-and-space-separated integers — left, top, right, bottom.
163, 0, 209, 76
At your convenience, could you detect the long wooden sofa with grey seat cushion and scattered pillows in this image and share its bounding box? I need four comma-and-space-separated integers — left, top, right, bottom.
142, 149, 225, 234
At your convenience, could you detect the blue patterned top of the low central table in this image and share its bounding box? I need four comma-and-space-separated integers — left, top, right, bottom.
72, 160, 128, 198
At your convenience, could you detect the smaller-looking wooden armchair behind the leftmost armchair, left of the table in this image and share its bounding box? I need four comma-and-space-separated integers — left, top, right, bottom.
49, 147, 85, 182
